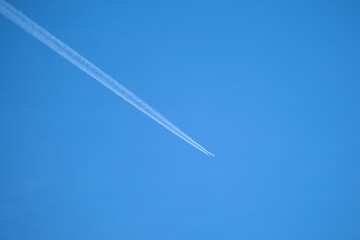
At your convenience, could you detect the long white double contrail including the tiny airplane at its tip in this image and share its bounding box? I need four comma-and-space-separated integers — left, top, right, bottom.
0, 0, 214, 157
